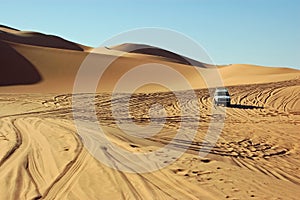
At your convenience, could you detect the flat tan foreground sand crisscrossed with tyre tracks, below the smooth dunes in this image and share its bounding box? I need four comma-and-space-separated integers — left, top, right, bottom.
0, 80, 300, 199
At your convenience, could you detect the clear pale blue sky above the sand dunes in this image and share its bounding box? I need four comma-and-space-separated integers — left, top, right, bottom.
0, 0, 300, 69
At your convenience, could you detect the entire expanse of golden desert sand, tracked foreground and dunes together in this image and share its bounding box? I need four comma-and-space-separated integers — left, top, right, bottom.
0, 26, 300, 199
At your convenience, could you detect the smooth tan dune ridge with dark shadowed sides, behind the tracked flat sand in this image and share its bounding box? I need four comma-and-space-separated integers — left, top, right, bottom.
0, 27, 300, 93
